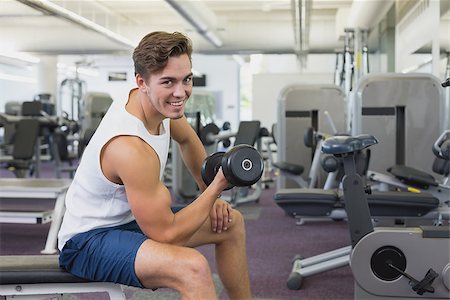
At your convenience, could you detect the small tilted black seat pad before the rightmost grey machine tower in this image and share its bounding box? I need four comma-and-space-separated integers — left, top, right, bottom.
387, 165, 438, 189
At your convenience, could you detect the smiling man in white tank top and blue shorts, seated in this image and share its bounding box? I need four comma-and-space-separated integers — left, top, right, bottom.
58, 32, 251, 299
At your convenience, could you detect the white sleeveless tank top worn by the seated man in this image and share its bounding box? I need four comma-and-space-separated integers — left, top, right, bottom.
58, 94, 170, 250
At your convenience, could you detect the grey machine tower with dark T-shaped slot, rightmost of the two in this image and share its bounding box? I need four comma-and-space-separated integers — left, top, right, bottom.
349, 73, 449, 173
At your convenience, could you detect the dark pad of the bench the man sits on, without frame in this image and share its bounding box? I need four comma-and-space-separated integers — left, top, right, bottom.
0, 255, 88, 285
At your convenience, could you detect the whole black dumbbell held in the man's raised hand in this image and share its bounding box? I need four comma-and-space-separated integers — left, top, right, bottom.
202, 144, 264, 190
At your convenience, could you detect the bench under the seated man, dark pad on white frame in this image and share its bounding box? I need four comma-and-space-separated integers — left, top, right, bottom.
0, 255, 126, 300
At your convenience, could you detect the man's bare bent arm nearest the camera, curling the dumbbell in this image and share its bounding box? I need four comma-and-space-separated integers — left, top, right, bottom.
102, 136, 227, 245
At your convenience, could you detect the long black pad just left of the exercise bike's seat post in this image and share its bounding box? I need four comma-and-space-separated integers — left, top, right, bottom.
274, 188, 339, 217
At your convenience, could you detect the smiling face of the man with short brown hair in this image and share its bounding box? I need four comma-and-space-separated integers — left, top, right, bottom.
146, 54, 193, 119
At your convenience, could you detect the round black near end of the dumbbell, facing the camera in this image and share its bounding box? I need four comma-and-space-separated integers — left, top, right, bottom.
222, 145, 264, 186
